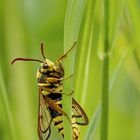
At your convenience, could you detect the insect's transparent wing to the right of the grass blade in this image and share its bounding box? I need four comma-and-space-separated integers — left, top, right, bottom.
72, 98, 89, 125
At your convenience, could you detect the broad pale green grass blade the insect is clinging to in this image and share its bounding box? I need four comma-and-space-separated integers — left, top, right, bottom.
62, 0, 85, 140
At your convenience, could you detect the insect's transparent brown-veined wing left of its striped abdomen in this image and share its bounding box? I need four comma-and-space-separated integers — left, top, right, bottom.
38, 89, 52, 140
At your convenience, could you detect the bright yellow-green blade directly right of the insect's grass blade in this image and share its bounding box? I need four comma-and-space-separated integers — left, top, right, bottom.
75, 0, 96, 106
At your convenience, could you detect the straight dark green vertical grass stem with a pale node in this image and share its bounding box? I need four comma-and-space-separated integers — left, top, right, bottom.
100, 0, 110, 140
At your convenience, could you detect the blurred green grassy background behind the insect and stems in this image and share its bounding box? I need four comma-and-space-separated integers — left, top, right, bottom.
0, 0, 140, 140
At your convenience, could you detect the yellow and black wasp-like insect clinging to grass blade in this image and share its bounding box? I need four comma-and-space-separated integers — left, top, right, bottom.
11, 42, 88, 140
